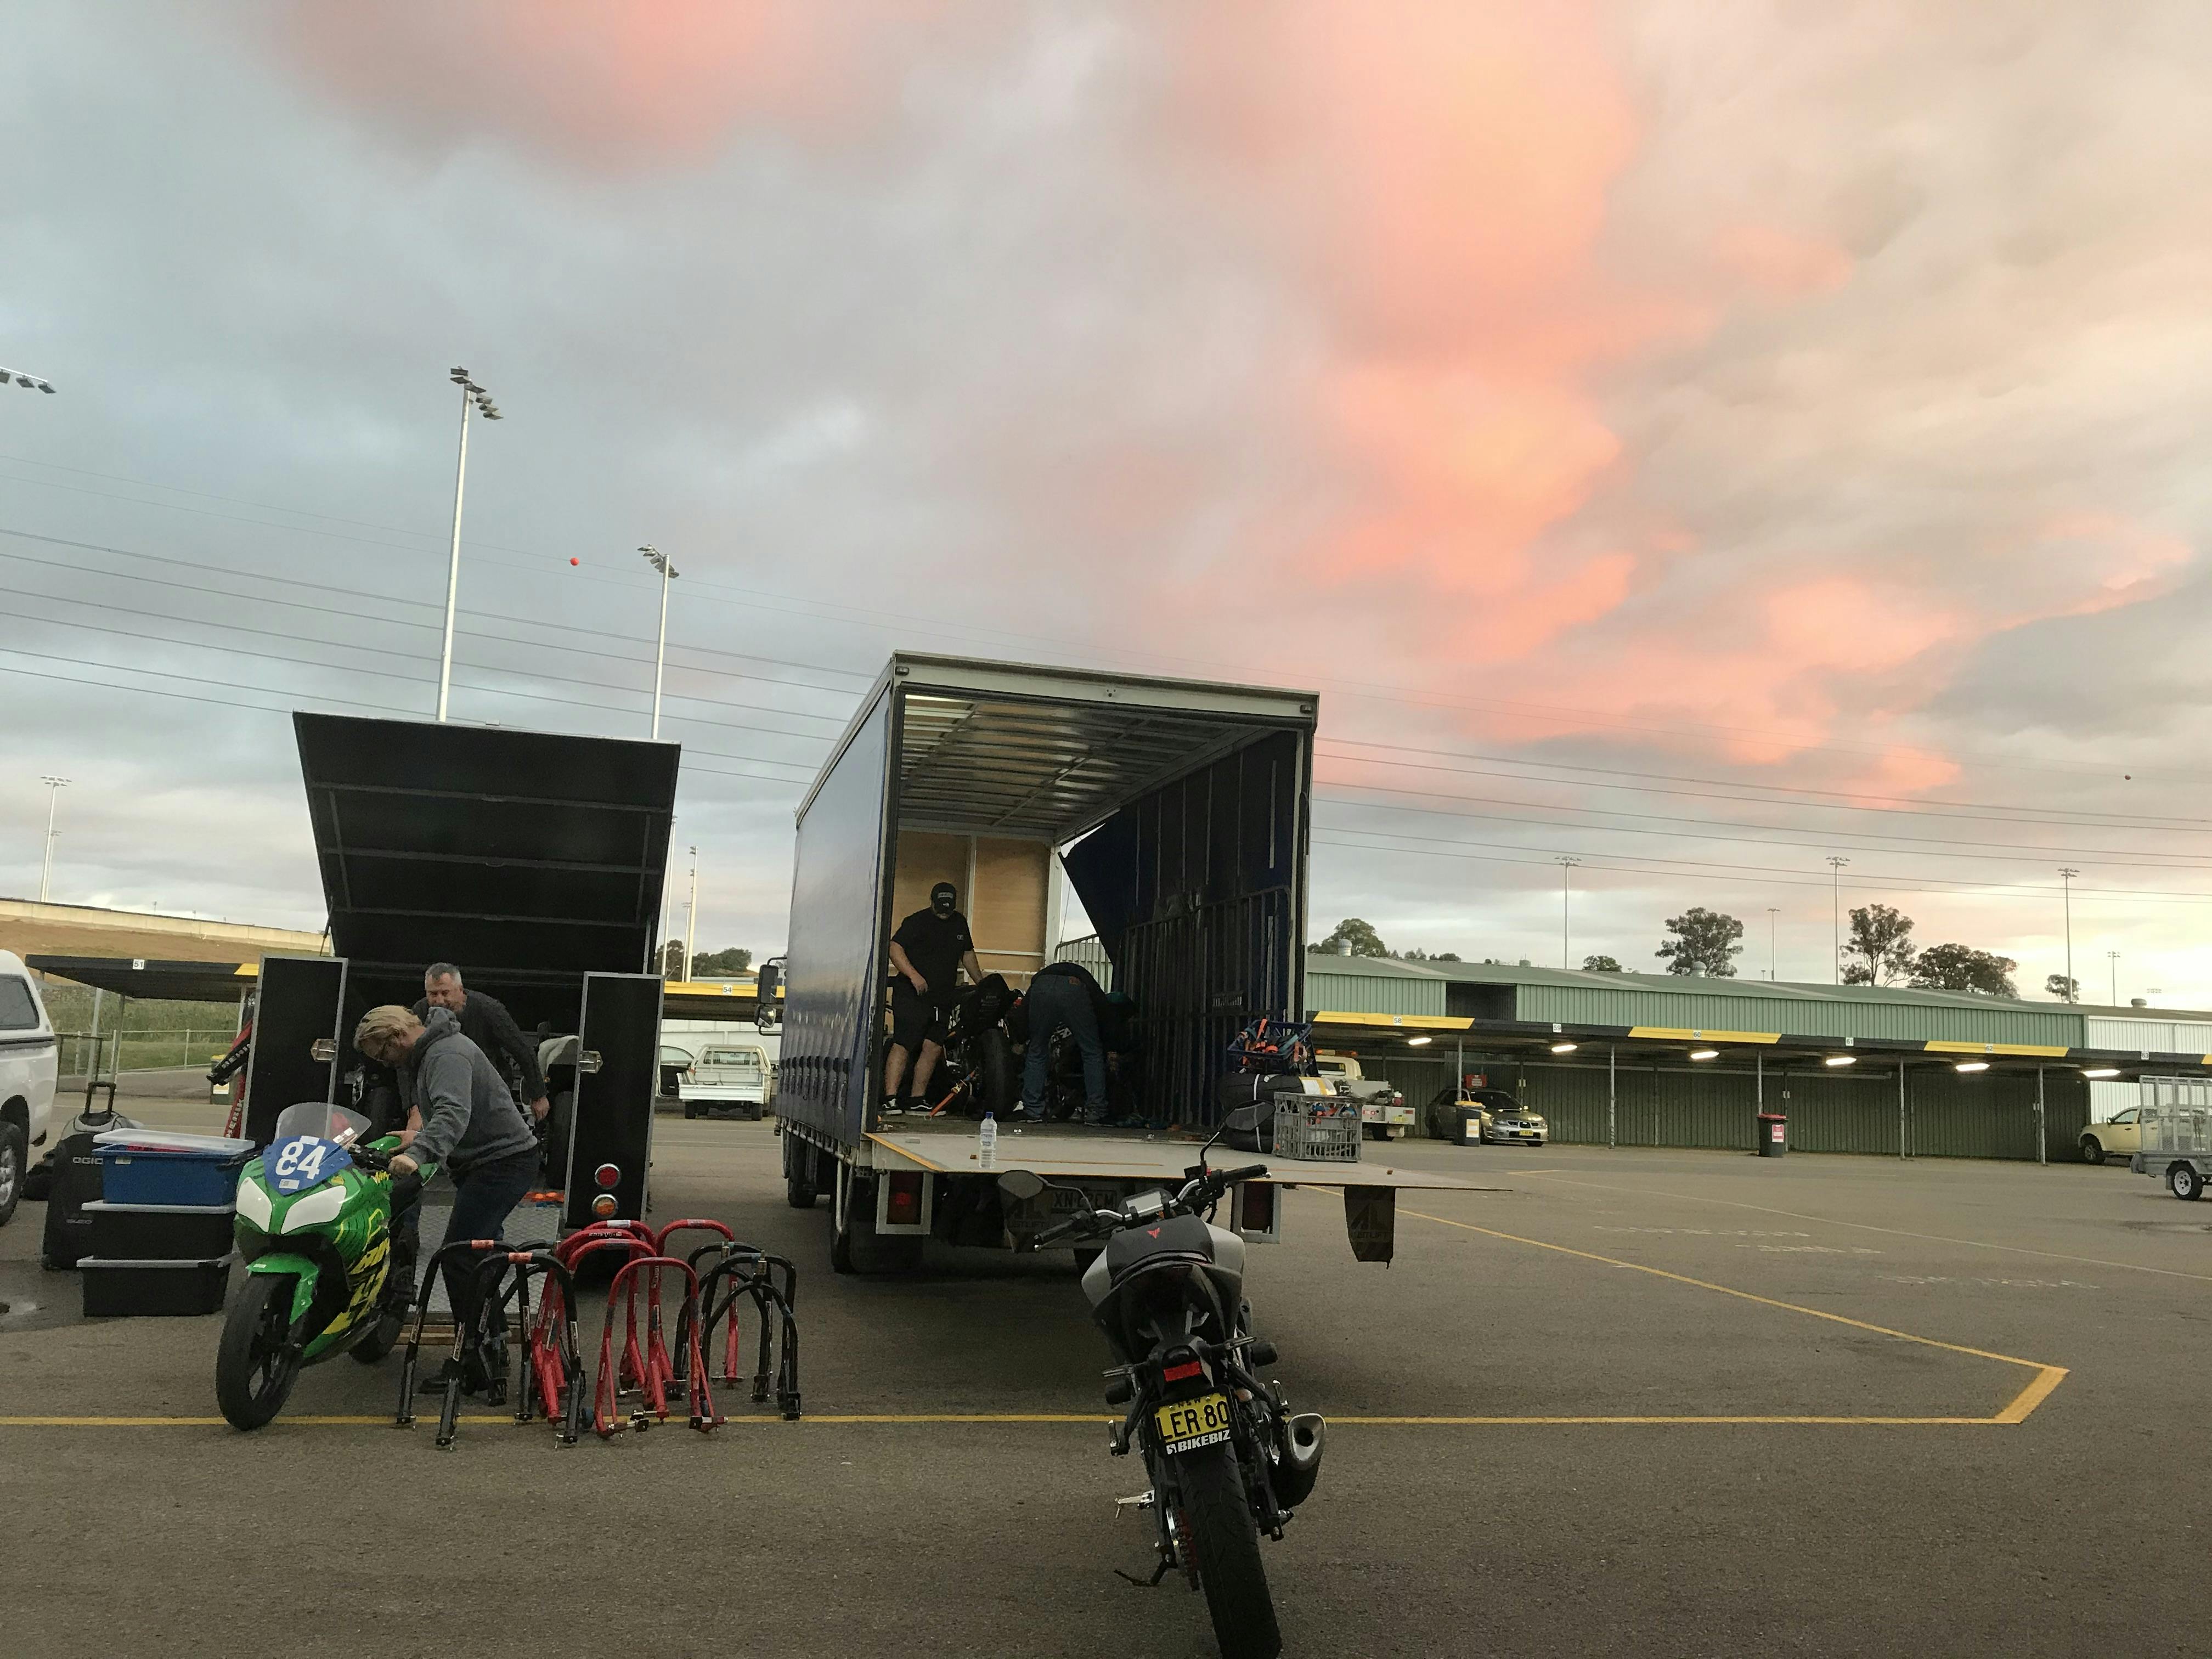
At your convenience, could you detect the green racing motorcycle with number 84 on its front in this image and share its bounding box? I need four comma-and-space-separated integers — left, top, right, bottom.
215, 1102, 433, 1429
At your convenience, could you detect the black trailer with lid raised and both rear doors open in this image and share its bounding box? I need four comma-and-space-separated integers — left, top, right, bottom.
246, 714, 681, 1226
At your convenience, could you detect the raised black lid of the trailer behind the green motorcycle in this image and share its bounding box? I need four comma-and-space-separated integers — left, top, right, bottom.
292, 714, 681, 1029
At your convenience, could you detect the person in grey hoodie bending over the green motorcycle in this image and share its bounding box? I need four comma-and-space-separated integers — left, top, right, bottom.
354, 1005, 538, 1389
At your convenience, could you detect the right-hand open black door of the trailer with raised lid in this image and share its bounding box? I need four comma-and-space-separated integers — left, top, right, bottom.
562, 973, 662, 1228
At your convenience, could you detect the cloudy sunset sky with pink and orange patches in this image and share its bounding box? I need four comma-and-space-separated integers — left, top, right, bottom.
0, 0, 2212, 1007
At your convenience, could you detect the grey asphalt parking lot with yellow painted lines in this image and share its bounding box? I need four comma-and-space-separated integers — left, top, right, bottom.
0, 1084, 2212, 1655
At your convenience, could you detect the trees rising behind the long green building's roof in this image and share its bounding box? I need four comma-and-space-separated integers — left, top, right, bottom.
1316, 905, 2035, 1002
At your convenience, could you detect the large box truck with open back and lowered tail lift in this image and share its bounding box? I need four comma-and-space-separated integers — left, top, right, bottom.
776, 652, 1466, 1272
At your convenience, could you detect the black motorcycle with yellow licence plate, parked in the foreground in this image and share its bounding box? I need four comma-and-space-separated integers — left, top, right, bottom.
997, 1110, 1325, 1659
